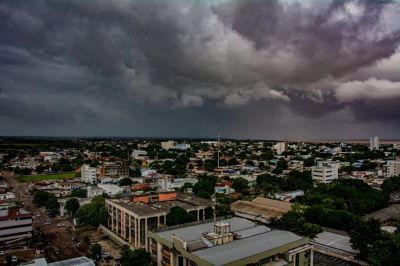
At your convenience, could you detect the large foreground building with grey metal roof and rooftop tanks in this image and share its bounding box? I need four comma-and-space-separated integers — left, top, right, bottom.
147, 217, 313, 266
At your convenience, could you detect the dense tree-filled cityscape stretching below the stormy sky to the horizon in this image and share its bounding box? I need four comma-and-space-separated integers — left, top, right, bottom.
0, 136, 400, 265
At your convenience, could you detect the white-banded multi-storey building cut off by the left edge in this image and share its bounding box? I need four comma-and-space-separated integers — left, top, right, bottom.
0, 207, 33, 247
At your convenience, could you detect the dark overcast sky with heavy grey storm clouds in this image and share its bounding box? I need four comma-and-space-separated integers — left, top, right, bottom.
0, 0, 400, 139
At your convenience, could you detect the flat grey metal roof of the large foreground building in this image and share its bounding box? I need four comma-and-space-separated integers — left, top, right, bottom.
156, 217, 303, 265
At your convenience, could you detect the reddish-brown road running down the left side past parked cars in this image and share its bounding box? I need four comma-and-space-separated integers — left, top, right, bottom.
3, 173, 85, 260
